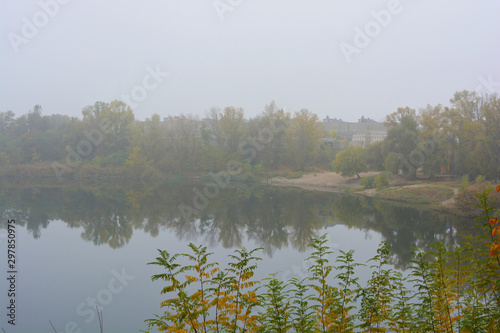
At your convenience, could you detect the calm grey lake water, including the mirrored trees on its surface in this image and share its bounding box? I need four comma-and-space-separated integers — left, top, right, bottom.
0, 184, 473, 333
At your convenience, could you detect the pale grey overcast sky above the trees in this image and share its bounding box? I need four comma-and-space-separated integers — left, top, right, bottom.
0, 0, 500, 121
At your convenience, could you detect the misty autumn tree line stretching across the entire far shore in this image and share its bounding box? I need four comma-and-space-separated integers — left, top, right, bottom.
0, 91, 500, 179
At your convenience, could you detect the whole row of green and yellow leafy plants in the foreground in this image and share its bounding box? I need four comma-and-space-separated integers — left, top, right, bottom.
142, 185, 500, 333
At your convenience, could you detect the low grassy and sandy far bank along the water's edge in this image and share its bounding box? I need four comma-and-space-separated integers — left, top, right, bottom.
0, 163, 500, 217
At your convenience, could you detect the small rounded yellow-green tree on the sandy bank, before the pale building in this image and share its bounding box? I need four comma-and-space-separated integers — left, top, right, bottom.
332, 145, 368, 178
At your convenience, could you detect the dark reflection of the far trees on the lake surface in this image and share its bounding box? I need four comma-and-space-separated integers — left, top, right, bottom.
0, 184, 474, 268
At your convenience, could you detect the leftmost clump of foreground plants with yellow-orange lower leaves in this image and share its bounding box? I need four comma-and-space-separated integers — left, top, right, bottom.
146, 244, 260, 332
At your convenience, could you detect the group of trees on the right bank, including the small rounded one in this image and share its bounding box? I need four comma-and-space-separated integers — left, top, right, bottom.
333, 91, 500, 180
